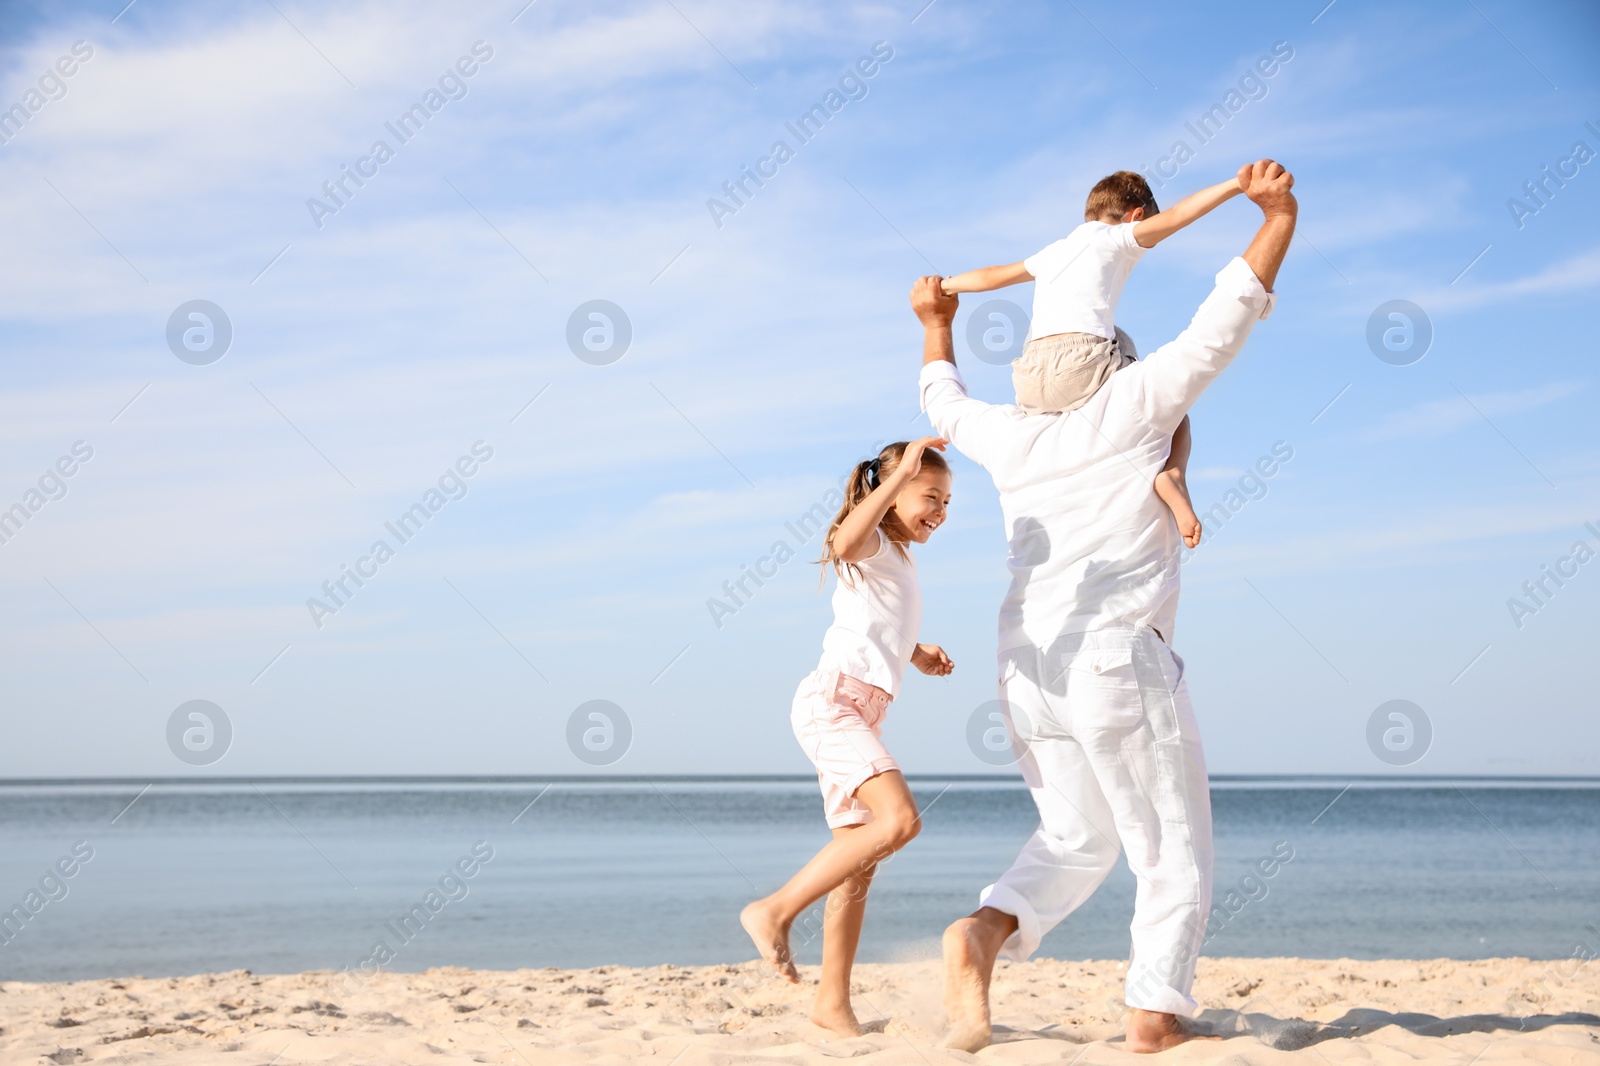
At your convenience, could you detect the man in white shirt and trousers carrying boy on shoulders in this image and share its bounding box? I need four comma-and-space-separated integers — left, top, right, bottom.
912, 160, 1299, 1052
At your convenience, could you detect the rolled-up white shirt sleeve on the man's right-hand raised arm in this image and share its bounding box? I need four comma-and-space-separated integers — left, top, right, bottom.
1122, 258, 1277, 434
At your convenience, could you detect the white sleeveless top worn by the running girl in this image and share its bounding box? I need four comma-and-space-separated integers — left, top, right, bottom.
819, 530, 922, 696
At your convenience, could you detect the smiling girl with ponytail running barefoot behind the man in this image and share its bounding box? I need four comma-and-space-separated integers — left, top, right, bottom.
739, 437, 955, 1036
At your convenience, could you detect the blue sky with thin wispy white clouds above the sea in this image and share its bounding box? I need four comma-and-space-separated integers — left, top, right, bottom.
0, 0, 1600, 776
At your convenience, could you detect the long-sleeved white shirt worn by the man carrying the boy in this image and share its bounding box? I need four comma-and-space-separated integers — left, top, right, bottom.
920, 259, 1275, 655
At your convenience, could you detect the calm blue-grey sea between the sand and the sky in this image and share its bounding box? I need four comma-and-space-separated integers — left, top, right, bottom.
0, 779, 1600, 980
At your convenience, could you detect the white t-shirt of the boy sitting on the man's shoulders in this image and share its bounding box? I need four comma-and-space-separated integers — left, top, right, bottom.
1022, 222, 1147, 341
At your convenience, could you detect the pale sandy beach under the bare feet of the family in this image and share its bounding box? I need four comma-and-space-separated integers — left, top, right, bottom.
0, 959, 1600, 1066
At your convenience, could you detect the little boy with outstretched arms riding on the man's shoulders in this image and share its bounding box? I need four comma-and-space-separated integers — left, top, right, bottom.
942, 170, 1240, 547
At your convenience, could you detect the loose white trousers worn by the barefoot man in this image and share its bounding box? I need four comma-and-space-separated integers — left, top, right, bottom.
981, 626, 1211, 1016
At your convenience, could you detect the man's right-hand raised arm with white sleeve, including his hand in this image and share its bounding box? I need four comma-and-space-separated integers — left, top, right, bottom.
1132, 158, 1299, 435
